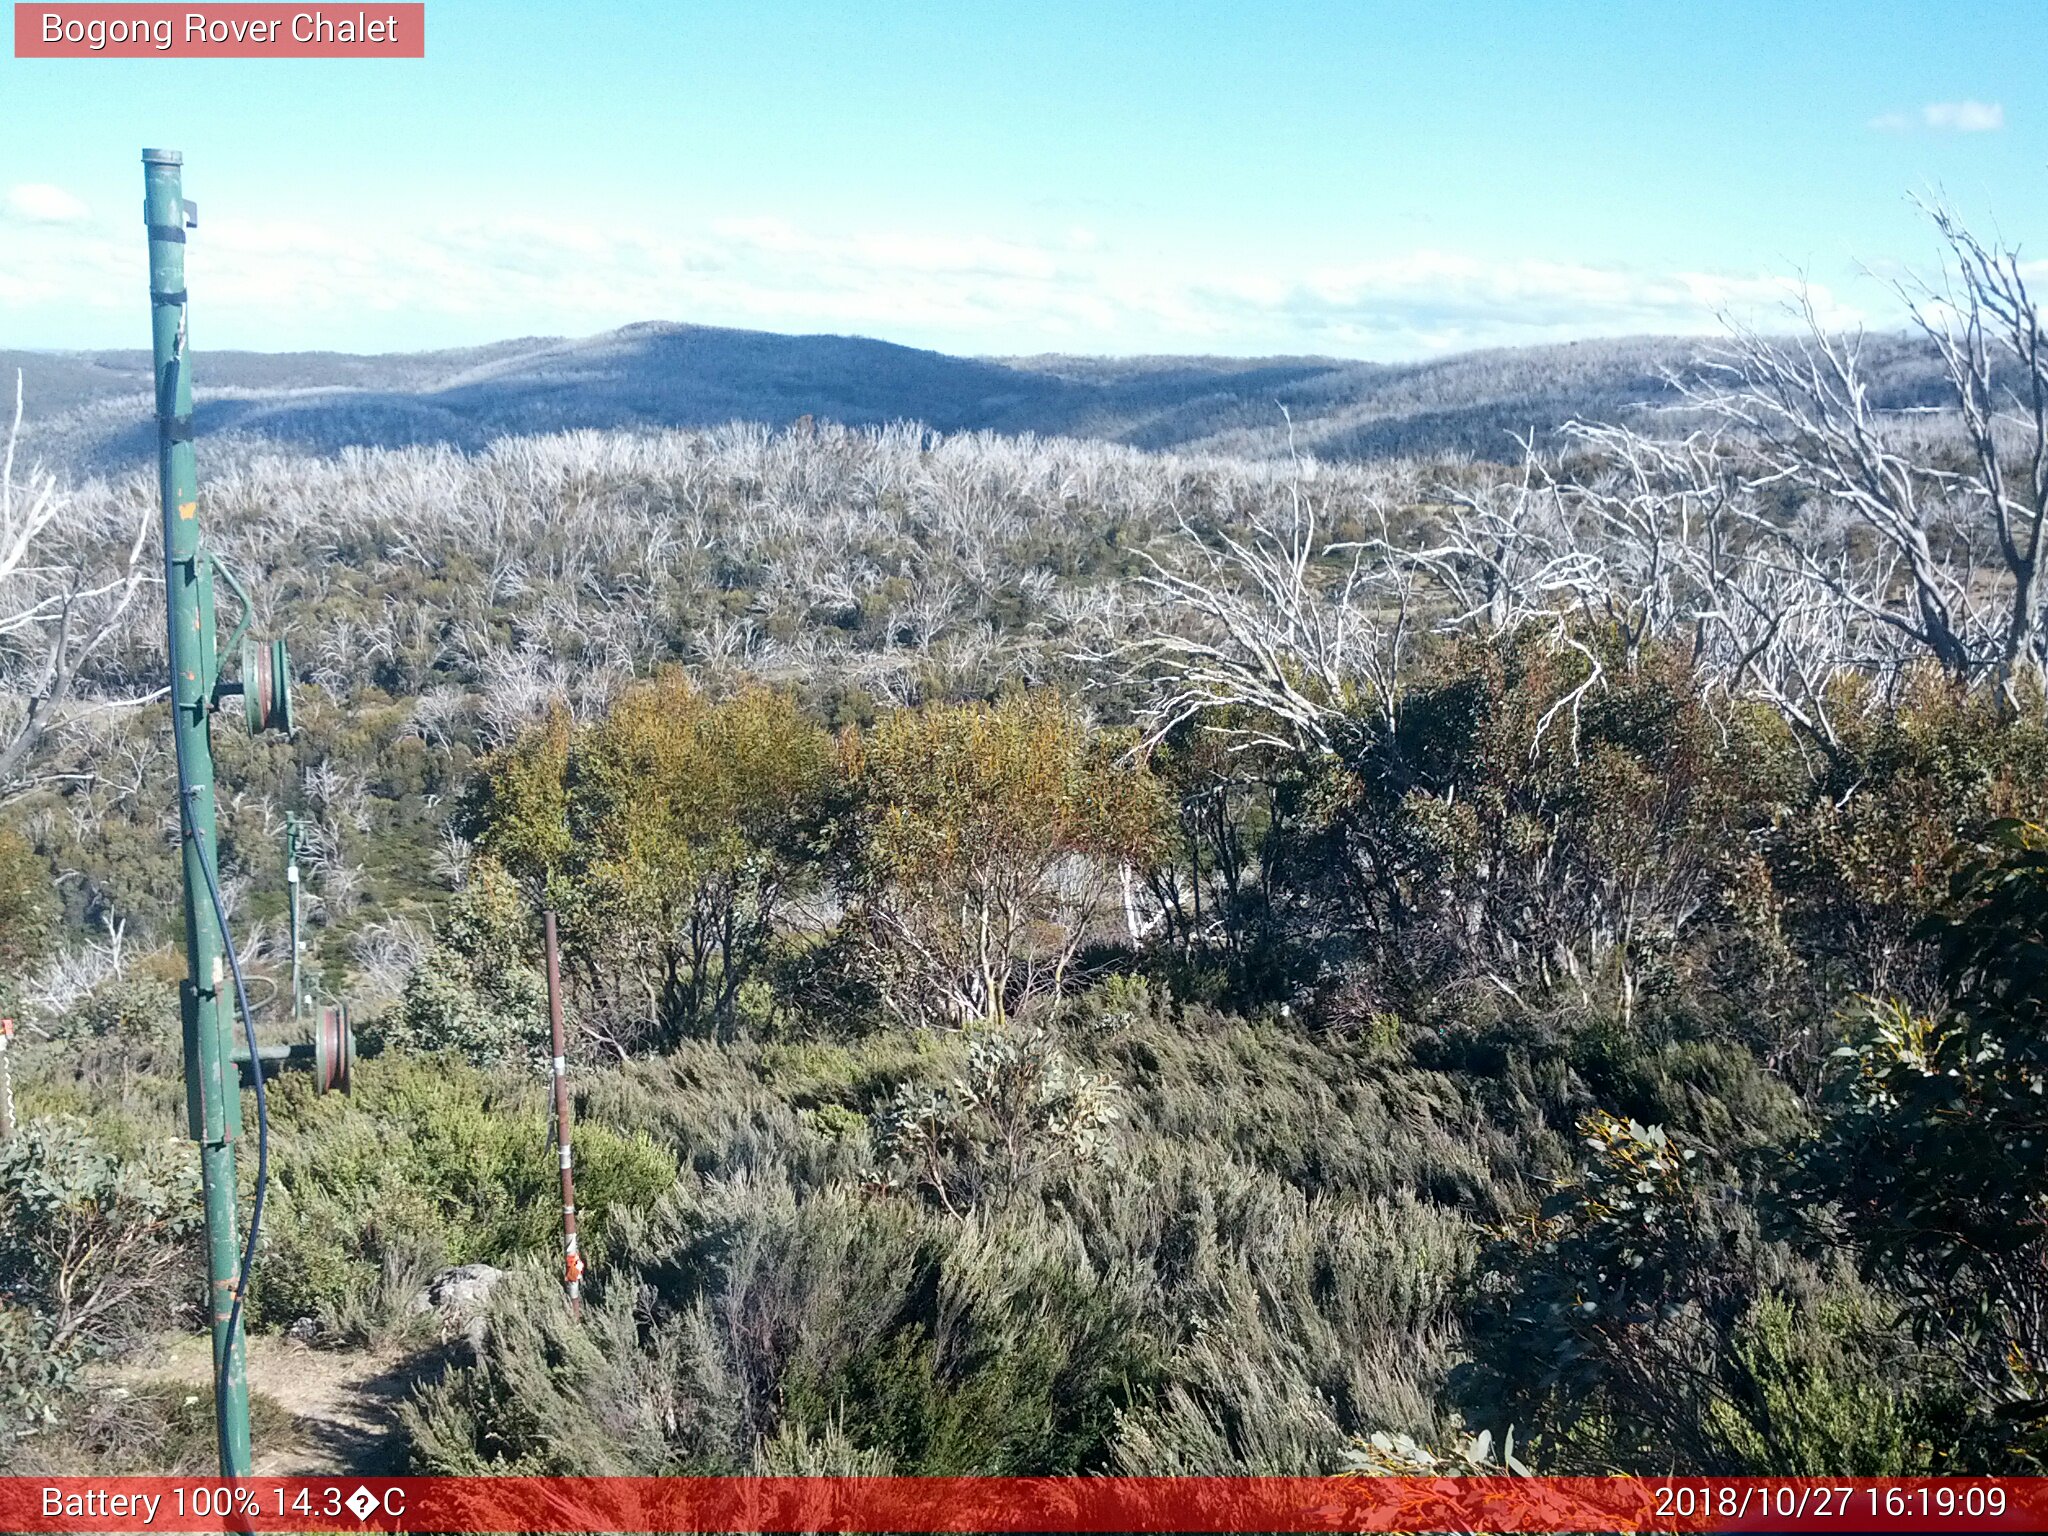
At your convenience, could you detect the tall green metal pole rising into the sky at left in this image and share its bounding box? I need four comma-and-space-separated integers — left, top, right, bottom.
141, 150, 250, 1477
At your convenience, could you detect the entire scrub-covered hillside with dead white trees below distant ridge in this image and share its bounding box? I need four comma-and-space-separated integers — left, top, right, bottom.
0, 214, 2048, 1475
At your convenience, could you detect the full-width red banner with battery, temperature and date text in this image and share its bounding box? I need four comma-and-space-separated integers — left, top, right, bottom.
0, 1477, 2048, 1532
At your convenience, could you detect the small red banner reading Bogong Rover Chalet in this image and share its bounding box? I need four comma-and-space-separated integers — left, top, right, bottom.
14, 0, 426, 59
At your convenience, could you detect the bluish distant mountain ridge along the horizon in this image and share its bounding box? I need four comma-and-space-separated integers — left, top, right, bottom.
0, 322, 1937, 469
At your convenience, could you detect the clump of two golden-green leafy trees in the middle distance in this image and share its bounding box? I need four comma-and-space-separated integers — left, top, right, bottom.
464, 684, 1165, 1053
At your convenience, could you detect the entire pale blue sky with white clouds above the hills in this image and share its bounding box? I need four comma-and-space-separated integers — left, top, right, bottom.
0, 0, 2048, 358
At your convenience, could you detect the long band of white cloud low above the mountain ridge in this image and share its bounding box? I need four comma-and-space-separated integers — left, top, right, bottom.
0, 184, 1868, 360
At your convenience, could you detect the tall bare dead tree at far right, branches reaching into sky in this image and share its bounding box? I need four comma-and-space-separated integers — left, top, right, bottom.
1679, 209, 2048, 702
